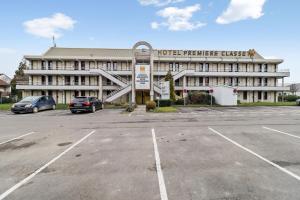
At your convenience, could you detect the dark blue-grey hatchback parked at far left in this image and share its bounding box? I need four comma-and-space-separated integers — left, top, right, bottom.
11, 96, 56, 113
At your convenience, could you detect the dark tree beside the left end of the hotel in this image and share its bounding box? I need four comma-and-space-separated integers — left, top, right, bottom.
11, 61, 28, 99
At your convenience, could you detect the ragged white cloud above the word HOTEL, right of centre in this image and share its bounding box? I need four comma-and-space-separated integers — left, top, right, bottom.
151, 4, 206, 31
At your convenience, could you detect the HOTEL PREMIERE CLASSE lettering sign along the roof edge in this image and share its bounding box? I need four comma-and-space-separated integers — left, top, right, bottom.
157, 49, 258, 58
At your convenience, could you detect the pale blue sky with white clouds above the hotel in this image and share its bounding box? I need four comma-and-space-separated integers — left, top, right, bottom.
0, 0, 300, 83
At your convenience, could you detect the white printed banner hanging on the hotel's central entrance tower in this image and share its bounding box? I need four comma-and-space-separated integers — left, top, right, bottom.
135, 65, 150, 90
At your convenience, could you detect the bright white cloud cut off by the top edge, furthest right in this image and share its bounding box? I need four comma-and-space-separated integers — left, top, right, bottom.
216, 0, 266, 24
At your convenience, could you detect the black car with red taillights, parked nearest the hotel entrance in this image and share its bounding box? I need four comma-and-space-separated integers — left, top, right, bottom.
69, 97, 102, 113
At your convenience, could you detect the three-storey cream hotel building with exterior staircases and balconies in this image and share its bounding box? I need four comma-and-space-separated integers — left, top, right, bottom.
17, 41, 290, 104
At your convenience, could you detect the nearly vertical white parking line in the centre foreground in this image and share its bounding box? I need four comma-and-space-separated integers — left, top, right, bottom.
152, 128, 168, 200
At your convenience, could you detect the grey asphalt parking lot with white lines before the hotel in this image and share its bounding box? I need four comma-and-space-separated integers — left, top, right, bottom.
0, 107, 300, 200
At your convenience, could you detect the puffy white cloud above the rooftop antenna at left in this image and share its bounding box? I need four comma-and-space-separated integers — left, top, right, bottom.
23, 13, 76, 38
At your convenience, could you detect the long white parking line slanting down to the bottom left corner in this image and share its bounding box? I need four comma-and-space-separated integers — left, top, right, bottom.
0, 130, 96, 200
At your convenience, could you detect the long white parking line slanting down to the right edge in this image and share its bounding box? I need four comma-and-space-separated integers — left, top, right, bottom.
208, 127, 300, 181
